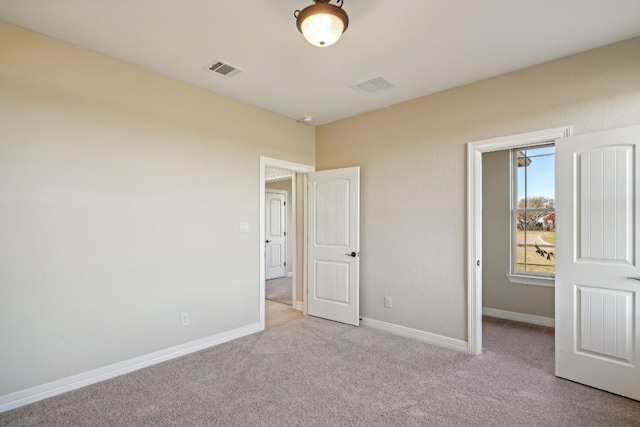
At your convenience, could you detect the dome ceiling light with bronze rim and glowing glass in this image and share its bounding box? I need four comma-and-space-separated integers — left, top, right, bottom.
293, 0, 349, 47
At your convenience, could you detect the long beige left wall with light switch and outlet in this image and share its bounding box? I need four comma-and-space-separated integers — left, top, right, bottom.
0, 23, 315, 396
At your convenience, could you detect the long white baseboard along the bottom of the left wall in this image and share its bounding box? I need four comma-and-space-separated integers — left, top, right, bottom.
0, 323, 260, 413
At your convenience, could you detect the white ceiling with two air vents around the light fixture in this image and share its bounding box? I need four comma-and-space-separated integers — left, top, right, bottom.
0, 0, 640, 125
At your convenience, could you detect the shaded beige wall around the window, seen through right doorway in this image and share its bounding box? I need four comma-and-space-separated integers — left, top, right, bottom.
482, 150, 555, 318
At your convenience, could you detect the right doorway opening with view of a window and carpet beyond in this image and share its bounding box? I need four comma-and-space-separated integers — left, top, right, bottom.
482, 143, 556, 366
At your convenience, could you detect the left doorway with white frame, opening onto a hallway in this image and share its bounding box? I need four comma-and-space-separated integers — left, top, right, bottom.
259, 157, 315, 330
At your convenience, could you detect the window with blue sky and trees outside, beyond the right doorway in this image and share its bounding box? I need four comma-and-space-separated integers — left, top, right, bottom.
511, 144, 556, 285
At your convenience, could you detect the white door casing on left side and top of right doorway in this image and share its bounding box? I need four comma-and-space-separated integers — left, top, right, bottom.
467, 126, 571, 354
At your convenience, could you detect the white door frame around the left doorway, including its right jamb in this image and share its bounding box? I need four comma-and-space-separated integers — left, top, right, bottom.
257, 156, 316, 331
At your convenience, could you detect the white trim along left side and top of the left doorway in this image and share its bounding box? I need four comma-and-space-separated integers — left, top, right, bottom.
258, 156, 315, 331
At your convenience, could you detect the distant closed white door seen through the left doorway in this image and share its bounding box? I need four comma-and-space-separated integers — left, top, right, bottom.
265, 192, 287, 280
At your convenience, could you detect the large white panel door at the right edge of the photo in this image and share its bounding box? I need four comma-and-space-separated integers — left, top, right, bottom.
556, 126, 640, 400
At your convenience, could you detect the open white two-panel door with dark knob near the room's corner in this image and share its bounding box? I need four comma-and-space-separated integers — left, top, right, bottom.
308, 167, 360, 326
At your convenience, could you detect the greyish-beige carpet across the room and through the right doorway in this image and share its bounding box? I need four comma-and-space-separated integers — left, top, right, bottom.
0, 317, 640, 427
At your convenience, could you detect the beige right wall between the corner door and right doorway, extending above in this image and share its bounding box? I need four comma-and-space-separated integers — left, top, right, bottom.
316, 38, 640, 340
